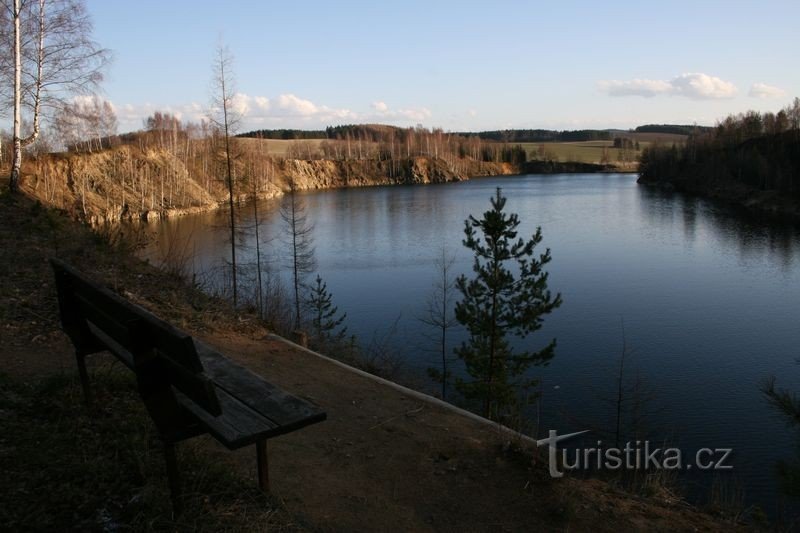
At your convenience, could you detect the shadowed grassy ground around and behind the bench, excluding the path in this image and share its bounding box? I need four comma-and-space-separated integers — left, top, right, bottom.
0, 189, 297, 531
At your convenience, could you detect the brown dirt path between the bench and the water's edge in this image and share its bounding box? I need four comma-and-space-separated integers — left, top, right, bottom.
184, 335, 736, 531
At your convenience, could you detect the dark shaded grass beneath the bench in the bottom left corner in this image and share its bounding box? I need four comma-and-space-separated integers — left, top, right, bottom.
0, 369, 300, 531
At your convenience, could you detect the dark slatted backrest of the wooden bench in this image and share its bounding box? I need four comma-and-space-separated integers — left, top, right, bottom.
50, 259, 221, 416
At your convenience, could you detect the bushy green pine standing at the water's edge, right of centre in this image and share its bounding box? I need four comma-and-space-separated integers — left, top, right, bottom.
455, 188, 561, 420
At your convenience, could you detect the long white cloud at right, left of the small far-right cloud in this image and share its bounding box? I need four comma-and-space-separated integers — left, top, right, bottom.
597, 72, 738, 100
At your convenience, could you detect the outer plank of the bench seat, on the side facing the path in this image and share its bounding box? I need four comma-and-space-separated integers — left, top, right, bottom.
195, 339, 327, 434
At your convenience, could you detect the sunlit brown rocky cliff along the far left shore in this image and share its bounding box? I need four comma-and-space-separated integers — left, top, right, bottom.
22, 146, 518, 225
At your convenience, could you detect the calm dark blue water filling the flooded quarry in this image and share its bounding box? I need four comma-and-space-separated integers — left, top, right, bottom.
144, 175, 800, 515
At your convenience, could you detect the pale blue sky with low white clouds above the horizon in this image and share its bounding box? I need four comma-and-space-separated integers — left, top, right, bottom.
86, 0, 800, 132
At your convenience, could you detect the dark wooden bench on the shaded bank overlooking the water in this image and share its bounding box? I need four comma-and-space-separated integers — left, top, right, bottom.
50, 259, 326, 512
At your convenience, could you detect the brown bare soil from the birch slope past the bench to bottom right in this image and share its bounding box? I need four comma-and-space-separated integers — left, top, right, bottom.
0, 186, 738, 531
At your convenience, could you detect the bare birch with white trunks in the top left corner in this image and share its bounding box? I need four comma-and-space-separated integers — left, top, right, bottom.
0, 0, 110, 192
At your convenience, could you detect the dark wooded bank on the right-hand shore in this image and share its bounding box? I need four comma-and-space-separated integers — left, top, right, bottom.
639, 98, 800, 200
